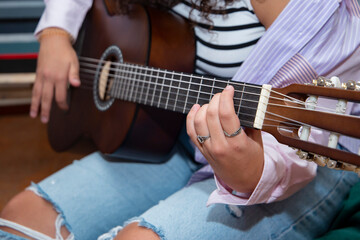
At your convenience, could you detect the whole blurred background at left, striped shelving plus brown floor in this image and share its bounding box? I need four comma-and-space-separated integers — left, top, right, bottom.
0, 0, 92, 211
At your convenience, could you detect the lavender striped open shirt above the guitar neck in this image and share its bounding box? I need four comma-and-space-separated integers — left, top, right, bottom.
234, 0, 360, 86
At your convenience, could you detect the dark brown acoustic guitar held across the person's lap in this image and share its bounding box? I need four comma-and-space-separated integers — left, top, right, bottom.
48, 0, 360, 173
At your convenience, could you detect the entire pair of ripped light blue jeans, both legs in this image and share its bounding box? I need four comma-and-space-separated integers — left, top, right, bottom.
0, 148, 358, 240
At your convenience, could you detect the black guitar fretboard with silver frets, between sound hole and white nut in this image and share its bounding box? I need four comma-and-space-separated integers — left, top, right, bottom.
110, 63, 262, 128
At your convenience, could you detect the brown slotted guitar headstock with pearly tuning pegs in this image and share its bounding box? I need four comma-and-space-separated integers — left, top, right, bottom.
262, 77, 360, 175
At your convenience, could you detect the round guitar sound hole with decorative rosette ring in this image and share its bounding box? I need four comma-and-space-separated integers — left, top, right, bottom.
93, 46, 123, 111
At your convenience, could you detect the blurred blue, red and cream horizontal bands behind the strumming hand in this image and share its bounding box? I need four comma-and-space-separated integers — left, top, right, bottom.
0, 0, 44, 111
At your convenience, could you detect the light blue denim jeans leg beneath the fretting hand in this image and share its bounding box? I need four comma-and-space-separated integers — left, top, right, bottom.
133, 168, 359, 240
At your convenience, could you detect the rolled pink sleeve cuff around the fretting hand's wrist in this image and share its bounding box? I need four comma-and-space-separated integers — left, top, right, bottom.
208, 132, 323, 205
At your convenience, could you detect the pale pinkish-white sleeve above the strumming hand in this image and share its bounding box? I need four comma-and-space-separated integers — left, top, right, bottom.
35, 0, 93, 39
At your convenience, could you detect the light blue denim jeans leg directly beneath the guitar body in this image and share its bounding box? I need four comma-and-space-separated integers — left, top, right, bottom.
35, 147, 197, 239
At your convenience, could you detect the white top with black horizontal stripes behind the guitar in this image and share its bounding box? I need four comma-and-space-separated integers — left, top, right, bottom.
173, 0, 265, 78
